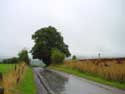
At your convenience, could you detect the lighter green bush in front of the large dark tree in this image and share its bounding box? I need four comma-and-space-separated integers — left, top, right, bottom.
51, 49, 65, 63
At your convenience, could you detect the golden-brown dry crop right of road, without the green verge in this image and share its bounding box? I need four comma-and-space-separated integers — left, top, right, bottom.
64, 59, 125, 82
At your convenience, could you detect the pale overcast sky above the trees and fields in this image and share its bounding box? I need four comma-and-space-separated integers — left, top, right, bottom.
0, 0, 125, 57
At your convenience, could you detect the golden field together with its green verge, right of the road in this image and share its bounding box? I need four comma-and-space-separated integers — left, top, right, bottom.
51, 58, 125, 89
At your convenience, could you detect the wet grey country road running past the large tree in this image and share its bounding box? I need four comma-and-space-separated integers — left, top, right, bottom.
34, 68, 125, 94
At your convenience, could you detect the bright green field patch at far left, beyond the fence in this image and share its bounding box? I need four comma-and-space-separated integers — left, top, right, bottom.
0, 64, 15, 74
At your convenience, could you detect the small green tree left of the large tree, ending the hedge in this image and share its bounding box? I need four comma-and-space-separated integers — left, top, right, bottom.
18, 49, 29, 65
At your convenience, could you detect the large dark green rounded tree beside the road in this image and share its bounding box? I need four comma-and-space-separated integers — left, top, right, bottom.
31, 26, 70, 66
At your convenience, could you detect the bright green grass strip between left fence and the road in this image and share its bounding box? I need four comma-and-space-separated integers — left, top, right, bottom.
17, 67, 36, 94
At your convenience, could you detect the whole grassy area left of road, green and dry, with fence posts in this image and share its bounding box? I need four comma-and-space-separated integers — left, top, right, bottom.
0, 62, 36, 94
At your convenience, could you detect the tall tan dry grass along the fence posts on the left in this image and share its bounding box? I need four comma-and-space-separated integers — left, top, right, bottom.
2, 63, 26, 94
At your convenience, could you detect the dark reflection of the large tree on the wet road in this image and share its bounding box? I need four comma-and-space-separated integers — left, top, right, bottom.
41, 70, 68, 94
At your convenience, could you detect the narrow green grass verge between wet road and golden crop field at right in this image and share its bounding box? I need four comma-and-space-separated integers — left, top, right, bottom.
49, 65, 125, 89
